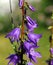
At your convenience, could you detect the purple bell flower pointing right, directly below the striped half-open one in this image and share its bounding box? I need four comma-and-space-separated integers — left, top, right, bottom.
27, 32, 42, 44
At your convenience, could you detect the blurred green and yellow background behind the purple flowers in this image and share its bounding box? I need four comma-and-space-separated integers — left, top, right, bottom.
0, 0, 53, 65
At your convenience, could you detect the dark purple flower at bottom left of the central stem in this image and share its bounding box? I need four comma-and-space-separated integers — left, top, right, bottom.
7, 54, 20, 65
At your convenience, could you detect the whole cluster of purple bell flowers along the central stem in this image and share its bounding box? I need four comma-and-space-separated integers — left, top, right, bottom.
5, 0, 42, 65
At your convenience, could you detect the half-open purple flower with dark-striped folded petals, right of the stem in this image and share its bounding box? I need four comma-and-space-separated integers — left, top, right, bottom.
26, 16, 38, 31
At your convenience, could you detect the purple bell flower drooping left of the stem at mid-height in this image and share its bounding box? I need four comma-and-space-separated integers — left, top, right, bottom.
6, 28, 20, 42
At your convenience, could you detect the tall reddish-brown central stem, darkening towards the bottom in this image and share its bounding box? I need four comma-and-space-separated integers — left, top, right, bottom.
21, 0, 24, 65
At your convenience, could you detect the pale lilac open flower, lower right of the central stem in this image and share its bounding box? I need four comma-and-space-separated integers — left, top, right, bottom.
27, 48, 41, 62
